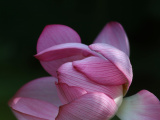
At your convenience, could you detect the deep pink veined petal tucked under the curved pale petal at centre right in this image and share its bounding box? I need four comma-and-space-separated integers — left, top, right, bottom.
73, 56, 127, 85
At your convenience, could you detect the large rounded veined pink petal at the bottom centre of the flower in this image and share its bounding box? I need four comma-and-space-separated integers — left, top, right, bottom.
56, 93, 117, 120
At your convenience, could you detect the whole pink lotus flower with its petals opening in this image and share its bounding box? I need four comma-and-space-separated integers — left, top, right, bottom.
9, 22, 160, 120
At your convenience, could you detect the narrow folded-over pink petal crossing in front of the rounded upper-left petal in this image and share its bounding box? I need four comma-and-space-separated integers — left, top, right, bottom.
35, 43, 93, 61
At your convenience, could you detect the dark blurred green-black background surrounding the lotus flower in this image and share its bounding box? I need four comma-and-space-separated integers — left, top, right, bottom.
0, 0, 160, 120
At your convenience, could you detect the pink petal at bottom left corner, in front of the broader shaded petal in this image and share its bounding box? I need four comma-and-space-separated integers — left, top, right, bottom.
9, 97, 58, 120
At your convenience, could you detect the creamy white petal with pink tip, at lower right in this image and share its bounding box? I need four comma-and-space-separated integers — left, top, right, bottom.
117, 90, 160, 120
